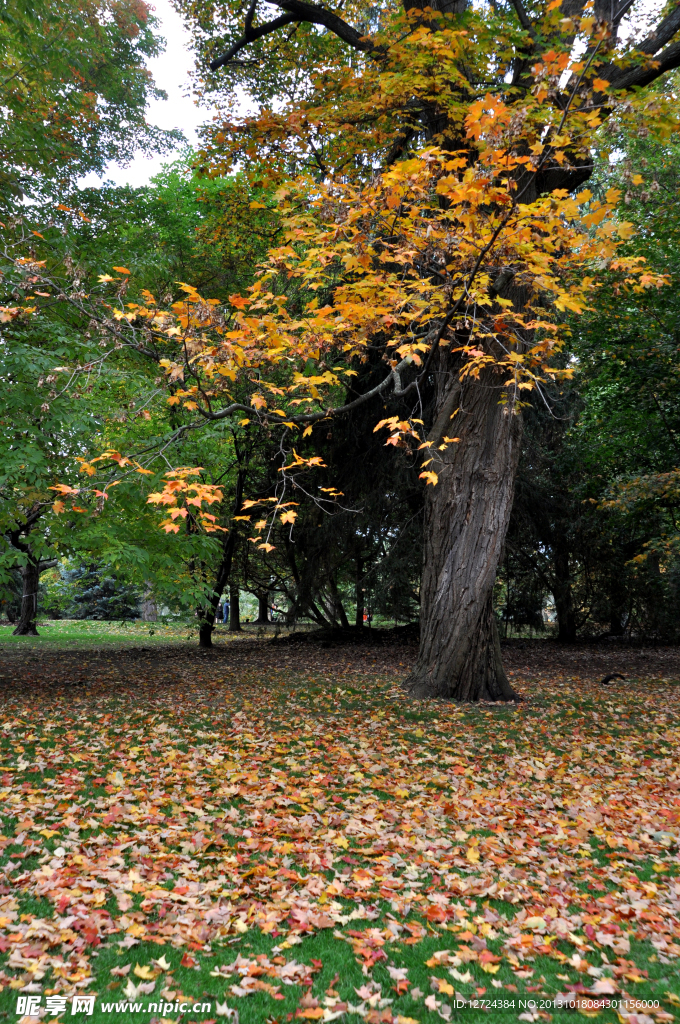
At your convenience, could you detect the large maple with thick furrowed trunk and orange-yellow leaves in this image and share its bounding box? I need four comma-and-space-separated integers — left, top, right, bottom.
11, 0, 676, 699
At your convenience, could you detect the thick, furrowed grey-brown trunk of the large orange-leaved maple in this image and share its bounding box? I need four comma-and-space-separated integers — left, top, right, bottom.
405, 357, 521, 700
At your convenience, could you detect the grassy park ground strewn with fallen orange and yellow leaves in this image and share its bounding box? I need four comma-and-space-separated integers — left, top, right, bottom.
0, 624, 680, 1024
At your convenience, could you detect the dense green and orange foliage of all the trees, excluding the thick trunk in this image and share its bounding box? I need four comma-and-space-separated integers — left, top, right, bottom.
0, 3, 680, 641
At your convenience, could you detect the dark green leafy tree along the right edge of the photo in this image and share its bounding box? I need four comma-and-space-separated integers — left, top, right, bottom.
575, 114, 680, 639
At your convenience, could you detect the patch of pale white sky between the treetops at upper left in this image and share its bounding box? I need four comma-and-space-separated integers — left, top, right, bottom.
79, 0, 205, 187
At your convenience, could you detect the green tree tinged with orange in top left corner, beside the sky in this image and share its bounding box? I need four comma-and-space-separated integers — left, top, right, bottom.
0, 0, 181, 213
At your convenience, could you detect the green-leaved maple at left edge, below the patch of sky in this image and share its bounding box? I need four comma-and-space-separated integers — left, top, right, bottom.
0, 237, 218, 634
